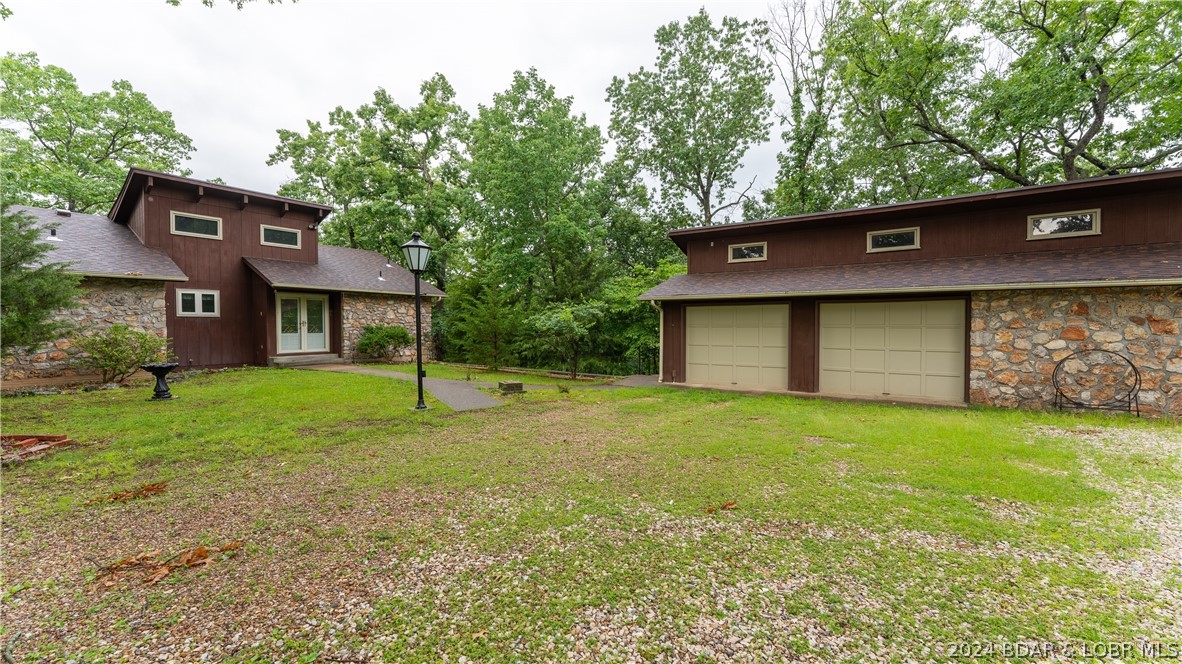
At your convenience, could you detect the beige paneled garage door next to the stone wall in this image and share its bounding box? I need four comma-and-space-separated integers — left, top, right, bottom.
820, 300, 966, 402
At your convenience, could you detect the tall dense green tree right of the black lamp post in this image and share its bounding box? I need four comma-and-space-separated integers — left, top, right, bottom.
468, 70, 610, 308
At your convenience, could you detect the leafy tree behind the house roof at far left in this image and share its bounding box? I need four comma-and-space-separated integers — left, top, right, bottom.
0, 53, 193, 213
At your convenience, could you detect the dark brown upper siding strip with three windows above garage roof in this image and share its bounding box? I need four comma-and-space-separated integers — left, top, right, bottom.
686, 190, 1182, 273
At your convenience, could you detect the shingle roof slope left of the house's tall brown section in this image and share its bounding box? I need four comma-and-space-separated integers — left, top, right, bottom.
9, 206, 189, 281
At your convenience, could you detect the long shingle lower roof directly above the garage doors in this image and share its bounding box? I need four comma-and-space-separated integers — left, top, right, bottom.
641, 242, 1182, 300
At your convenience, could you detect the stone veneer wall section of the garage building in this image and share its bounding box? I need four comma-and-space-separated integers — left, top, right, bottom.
969, 286, 1182, 416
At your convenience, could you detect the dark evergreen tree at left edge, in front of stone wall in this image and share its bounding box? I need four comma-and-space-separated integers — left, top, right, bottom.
0, 206, 80, 356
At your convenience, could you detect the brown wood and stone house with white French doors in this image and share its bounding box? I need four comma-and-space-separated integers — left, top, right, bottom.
4, 169, 443, 383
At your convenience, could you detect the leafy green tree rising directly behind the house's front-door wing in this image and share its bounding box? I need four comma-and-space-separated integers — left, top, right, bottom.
267, 74, 468, 288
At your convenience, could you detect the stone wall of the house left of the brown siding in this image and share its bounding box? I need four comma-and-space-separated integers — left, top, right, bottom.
2, 278, 168, 382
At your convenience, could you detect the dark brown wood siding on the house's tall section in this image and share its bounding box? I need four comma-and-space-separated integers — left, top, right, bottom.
141, 184, 323, 366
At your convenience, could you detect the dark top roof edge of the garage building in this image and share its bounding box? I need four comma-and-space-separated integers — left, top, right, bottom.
669, 168, 1182, 242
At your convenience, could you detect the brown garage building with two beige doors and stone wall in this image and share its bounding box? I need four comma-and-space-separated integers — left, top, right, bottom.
642, 169, 1182, 415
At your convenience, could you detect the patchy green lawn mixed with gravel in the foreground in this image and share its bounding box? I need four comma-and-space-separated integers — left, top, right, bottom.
0, 370, 1182, 662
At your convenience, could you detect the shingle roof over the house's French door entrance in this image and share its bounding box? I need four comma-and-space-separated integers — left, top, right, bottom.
242, 245, 443, 298
